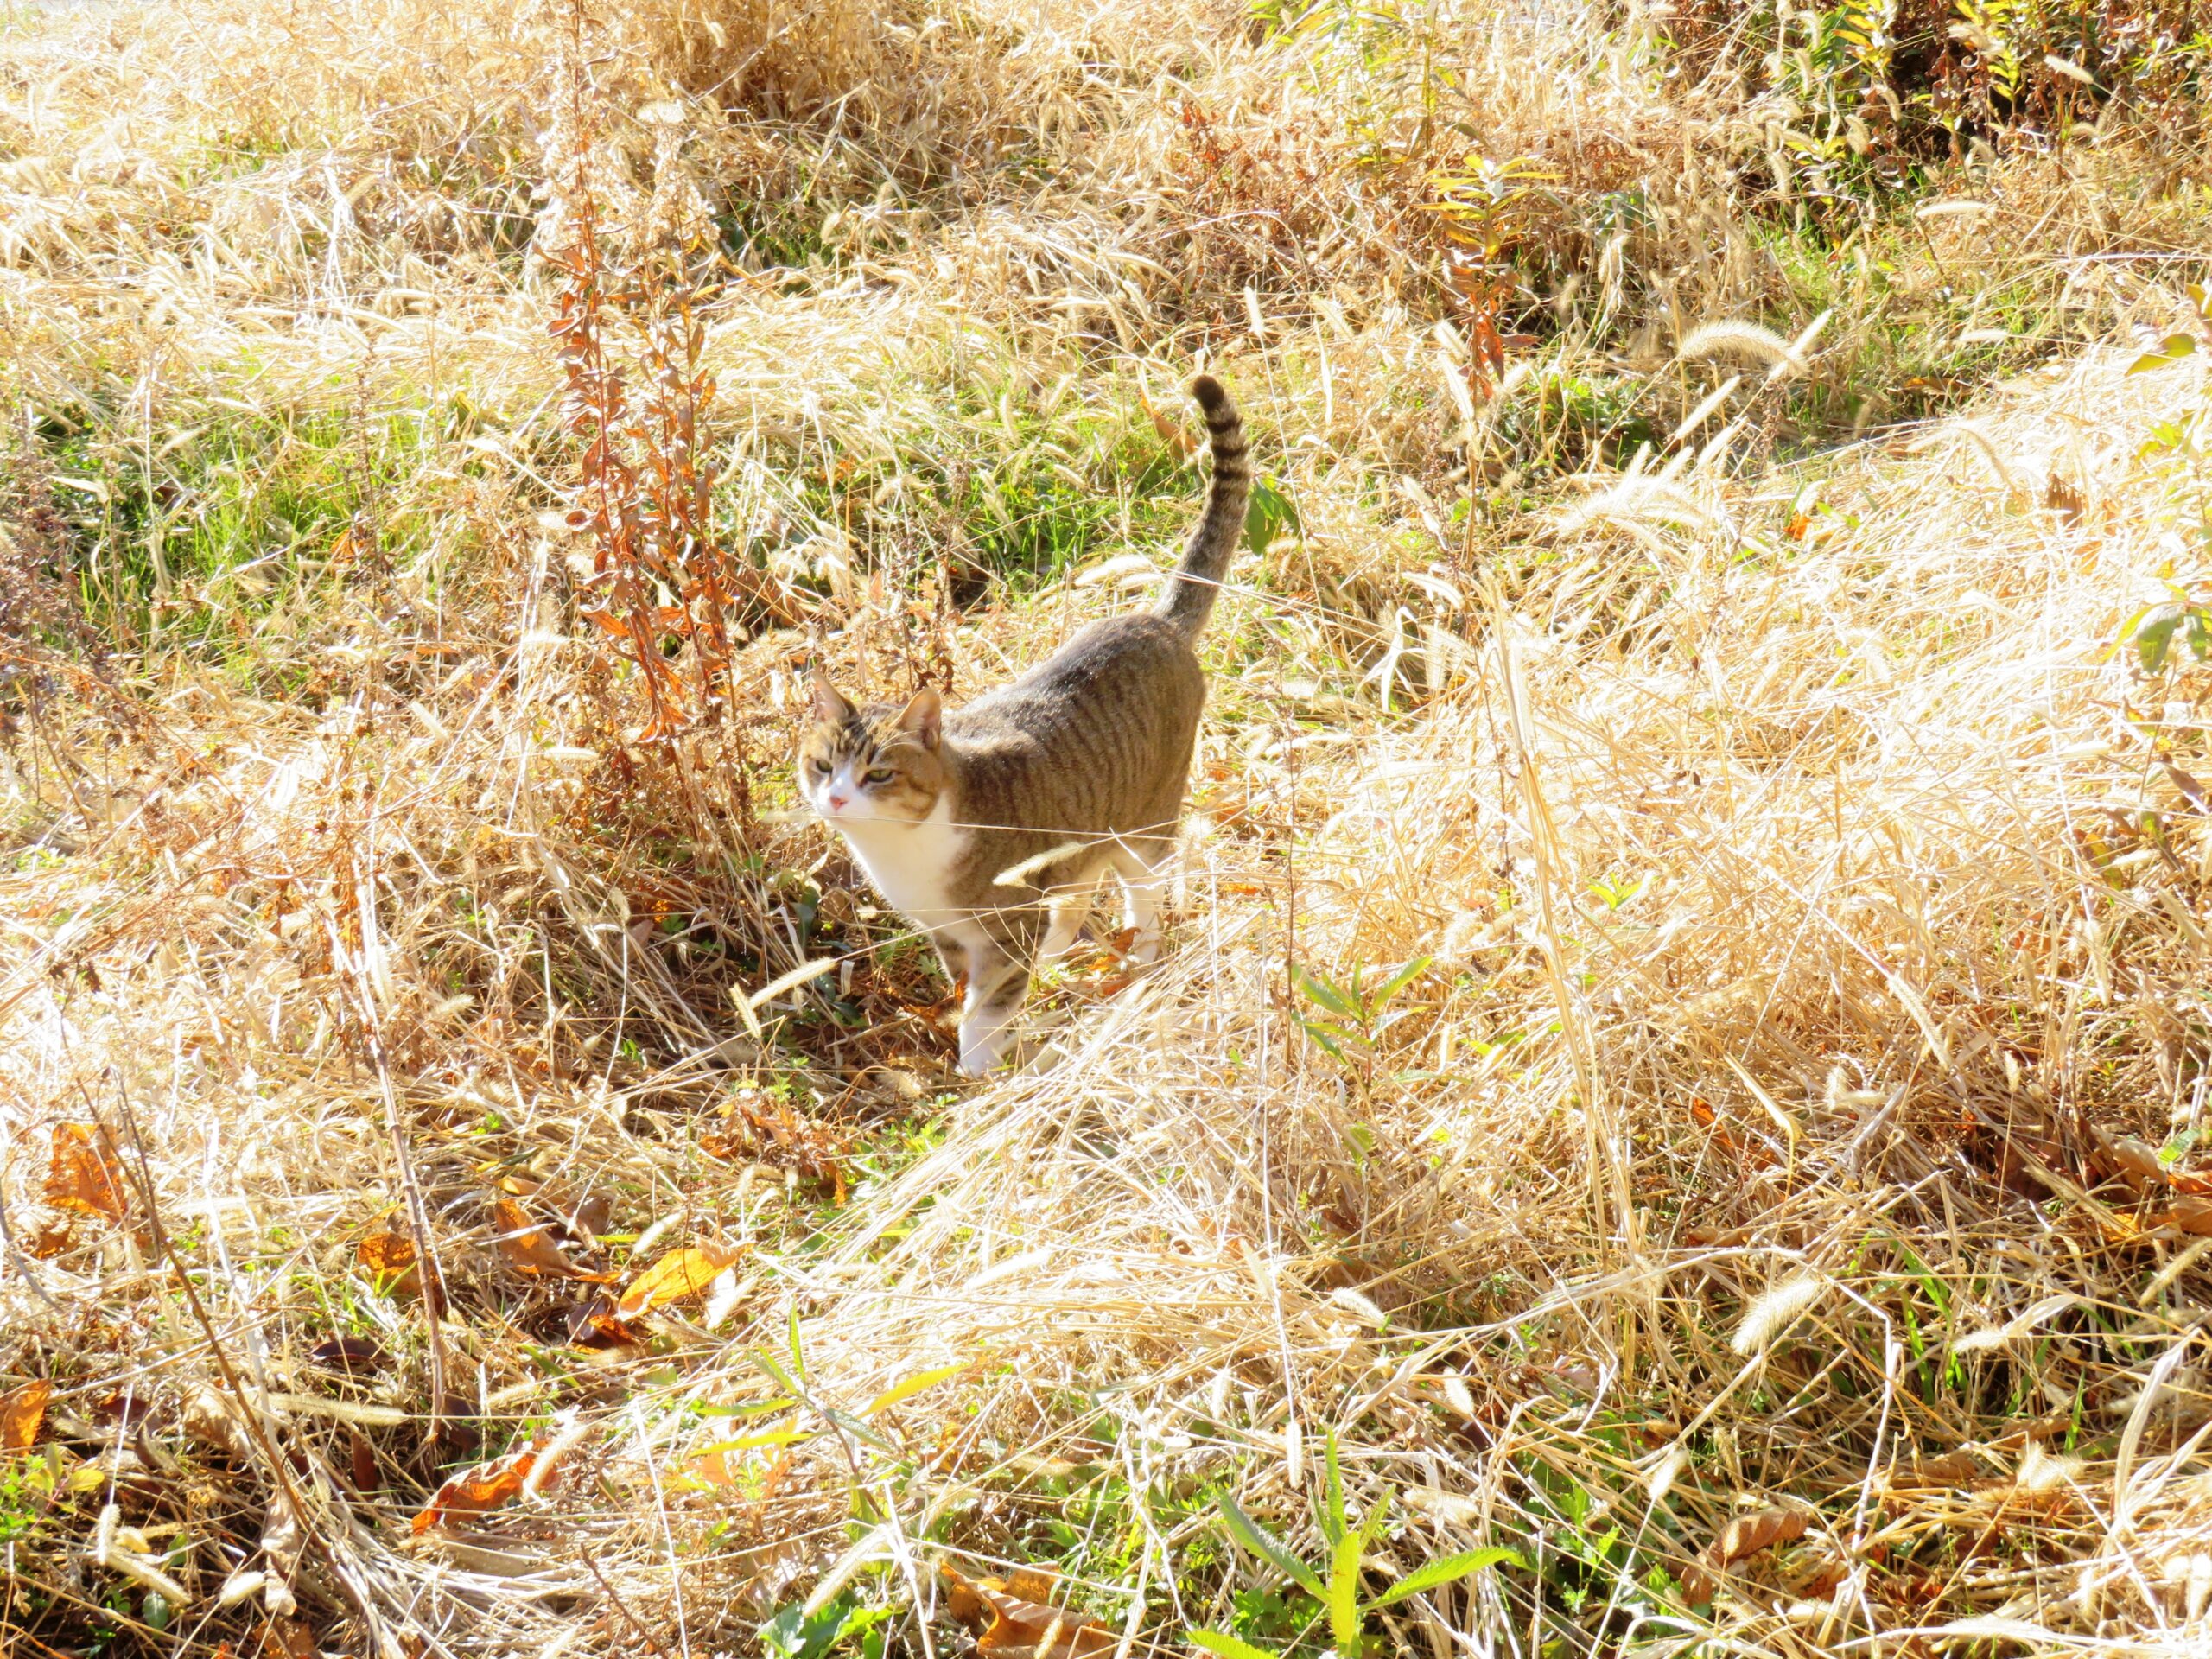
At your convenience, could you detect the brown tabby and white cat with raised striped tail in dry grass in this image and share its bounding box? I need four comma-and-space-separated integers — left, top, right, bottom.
798, 376, 1252, 1077
